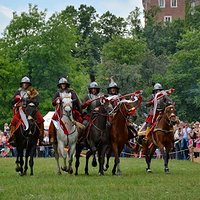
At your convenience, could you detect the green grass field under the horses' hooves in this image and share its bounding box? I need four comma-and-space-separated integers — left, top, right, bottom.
0, 158, 200, 200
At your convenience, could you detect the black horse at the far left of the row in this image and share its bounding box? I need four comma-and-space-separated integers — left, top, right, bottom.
14, 103, 39, 176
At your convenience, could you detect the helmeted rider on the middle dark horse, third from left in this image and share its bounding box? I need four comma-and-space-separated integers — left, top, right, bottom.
82, 81, 102, 126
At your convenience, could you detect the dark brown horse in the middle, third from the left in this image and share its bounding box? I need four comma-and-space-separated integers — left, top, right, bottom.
76, 97, 110, 176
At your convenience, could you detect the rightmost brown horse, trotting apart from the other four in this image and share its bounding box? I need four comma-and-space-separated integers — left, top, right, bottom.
143, 105, 176, 173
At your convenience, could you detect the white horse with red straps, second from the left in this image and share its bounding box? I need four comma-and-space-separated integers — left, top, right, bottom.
53, 93, 78, 174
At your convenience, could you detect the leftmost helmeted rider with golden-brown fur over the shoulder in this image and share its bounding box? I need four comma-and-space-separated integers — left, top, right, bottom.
9, 76, 44, 145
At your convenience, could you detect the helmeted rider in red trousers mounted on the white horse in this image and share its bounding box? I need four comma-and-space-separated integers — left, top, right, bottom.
49, 77, 82, 144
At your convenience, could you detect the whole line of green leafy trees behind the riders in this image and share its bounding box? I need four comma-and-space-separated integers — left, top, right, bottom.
0, 4, 200, 124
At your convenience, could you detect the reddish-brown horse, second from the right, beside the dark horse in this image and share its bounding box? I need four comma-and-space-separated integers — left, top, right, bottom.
110, 100, 135, 175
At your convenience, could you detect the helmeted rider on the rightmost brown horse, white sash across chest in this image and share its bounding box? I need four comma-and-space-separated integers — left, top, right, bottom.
145, 83, 173, 140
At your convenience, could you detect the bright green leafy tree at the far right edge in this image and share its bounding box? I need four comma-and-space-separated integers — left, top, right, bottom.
165, 30, 200, 121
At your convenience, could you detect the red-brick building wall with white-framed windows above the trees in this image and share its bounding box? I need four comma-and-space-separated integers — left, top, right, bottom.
143, 0, 185, 22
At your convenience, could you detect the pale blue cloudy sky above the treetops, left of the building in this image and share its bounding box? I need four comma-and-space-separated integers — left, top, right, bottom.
0, 0, 143, 36
